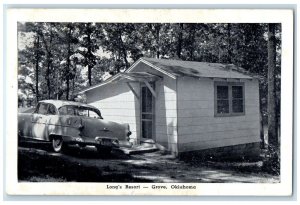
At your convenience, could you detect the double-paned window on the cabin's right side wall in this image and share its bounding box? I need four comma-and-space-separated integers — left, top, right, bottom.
215, 82, 245, 116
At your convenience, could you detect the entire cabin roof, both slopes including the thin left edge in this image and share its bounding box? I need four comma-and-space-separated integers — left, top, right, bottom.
79, 57, 253, 94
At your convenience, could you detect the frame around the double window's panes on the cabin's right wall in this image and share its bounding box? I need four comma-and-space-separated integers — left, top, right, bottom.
214, 81, 246, 117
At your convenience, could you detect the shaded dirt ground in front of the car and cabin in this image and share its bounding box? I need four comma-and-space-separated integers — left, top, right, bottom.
18, 142, 279, 183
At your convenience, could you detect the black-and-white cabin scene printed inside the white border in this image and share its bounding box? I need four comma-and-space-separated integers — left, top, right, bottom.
18, 22, 281, 183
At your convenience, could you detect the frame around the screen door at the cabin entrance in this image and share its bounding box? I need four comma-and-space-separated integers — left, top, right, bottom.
139, 81, 156, 142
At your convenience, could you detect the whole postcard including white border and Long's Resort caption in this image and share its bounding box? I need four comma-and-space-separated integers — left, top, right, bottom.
4, 8, 294, 196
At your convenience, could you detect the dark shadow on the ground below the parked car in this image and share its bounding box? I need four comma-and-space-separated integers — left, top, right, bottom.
18, 143, 151, 182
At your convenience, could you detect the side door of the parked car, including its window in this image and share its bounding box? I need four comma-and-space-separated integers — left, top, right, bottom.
31, 103, 49, 140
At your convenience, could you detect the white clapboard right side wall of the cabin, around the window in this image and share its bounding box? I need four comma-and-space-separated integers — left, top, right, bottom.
177, 77, 260, 152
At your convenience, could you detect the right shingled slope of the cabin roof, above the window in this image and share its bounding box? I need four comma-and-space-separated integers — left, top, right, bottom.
141, 57, 252, 79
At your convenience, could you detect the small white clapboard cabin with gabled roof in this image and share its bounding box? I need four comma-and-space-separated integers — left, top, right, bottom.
80, 58, 261, 159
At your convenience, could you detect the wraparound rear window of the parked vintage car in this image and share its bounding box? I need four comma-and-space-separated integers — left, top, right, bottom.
58, 105, 102, 119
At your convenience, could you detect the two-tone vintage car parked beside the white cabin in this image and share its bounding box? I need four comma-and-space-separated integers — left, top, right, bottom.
18, 100, 131, 153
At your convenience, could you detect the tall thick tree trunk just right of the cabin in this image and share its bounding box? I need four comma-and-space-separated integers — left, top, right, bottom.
268, 23, 278, 149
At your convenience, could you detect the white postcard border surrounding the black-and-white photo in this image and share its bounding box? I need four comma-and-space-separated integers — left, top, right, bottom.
4, 9, 293, 196
